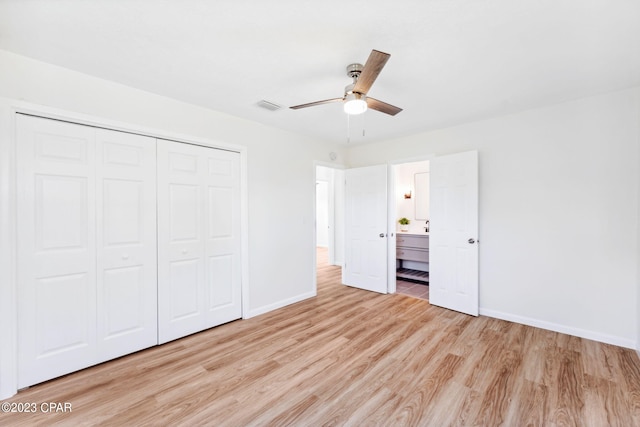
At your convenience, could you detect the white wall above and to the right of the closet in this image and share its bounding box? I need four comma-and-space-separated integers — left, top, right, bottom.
0, 51, 343, 324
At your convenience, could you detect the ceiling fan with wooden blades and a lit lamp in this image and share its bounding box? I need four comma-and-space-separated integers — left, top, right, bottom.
290, 49, 402, 116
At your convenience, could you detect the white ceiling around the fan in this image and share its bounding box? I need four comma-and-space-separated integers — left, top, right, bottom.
0, 0, 640, 143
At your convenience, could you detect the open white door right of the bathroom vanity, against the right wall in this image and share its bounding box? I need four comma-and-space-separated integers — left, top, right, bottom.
429, 151, 478, 316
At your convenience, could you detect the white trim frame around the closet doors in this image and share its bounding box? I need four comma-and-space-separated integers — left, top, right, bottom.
0, 97, 250, 399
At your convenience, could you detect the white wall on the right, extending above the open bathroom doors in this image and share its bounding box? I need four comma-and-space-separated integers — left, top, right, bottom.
347, 88, 640, 347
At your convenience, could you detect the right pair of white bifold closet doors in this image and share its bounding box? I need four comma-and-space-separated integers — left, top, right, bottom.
158, 140, 242, 343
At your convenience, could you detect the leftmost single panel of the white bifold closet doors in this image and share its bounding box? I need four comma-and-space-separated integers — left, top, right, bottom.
16, 115, 96, 387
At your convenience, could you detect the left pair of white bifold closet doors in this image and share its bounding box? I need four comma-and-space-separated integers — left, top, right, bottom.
16, 115, 157, 387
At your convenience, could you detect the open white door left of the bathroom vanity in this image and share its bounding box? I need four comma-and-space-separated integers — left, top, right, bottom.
342, 165, 388, 294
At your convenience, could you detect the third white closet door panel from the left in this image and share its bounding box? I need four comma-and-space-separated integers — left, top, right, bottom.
158, 140, 205, 343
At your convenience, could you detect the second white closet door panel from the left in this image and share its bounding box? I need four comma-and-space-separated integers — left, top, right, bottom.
96, 129, 157, 361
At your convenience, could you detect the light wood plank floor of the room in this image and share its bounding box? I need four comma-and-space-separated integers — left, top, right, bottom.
5, 249, 640, 427
